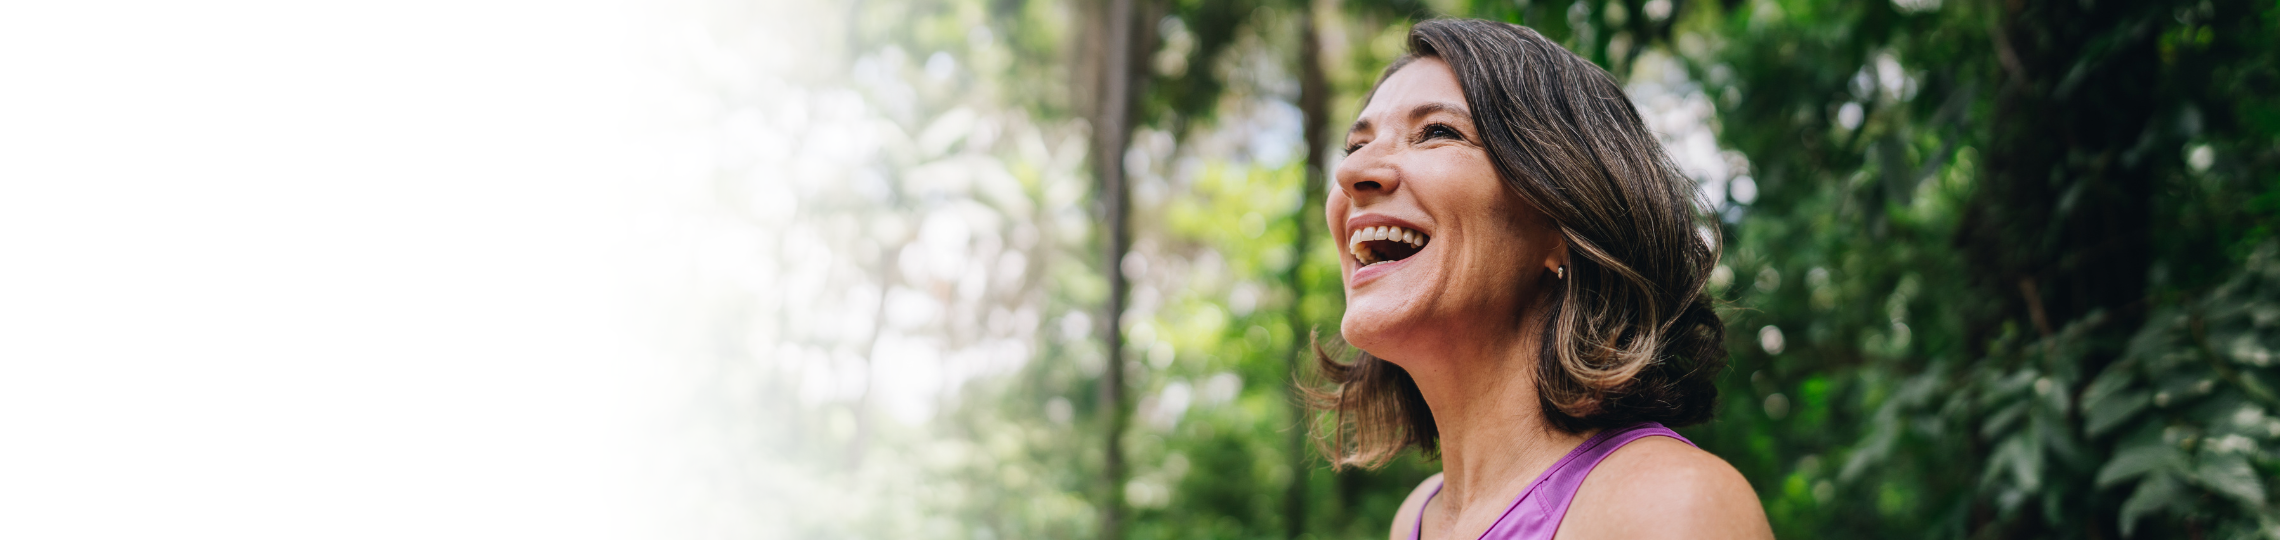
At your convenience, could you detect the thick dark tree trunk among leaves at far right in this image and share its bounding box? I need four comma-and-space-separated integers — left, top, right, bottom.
1956, 0, 2177, 538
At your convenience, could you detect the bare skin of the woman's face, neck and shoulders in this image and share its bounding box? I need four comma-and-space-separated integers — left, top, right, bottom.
1325, 57, 1772, 540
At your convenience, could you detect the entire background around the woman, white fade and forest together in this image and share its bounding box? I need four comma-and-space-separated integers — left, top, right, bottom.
0, 0, 2280, 538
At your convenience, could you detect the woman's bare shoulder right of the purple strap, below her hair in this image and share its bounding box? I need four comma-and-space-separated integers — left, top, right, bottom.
1560, 437, 1774, 538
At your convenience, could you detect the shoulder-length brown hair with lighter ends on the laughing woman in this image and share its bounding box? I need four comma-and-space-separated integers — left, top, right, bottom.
1304, 18, 1726, 467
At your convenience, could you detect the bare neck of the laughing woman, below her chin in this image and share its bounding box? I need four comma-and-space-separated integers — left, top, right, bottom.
1404, 324, 1591, 515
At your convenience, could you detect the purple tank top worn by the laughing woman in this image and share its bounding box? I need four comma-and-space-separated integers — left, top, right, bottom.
1409, 422, 1694, 540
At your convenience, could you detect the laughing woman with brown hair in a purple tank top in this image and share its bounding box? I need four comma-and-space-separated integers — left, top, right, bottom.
1316, 21, 1772, 540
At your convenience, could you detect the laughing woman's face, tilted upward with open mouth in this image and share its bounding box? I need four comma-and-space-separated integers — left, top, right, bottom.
1325, 57, 1564, 362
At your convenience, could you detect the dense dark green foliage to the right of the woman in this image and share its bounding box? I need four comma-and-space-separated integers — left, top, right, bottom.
1674, 2, 2280, 538
